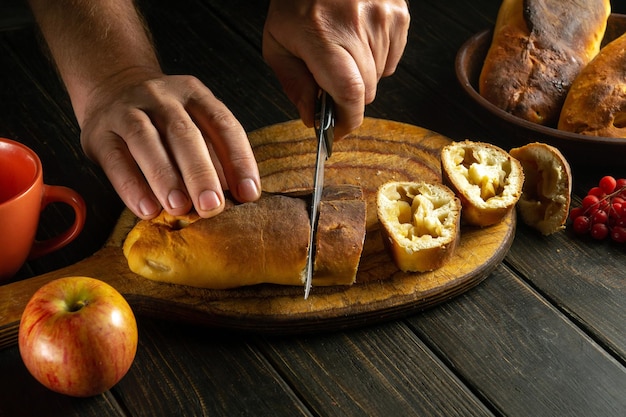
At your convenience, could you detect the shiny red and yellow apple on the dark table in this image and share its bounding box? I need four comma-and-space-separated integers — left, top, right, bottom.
19, 277, 137, 397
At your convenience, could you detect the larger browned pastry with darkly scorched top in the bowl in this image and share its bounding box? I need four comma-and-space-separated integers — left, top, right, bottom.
479, 0, 611, 126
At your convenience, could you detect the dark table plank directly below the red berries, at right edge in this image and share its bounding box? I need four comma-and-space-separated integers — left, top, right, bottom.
506, 223, 626, 363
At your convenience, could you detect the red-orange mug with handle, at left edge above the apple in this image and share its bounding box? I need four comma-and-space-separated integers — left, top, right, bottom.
0, 138, 86, 281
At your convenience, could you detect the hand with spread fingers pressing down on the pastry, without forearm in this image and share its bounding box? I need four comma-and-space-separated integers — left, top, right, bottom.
79, 68, 261, 219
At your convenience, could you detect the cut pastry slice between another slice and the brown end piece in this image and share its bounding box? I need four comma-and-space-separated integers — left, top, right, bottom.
441, 140, 524, 226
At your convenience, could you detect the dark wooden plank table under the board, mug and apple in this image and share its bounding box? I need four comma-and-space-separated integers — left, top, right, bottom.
0, 0, 626, 417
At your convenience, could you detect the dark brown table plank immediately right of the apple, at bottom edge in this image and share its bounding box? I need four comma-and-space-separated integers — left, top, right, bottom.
113, 319, 310, 416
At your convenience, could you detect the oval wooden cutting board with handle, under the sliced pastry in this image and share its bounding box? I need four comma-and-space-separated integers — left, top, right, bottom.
0, 118, 515, 347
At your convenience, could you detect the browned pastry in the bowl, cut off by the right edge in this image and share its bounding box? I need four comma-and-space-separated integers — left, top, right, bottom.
558, 34, 626, 138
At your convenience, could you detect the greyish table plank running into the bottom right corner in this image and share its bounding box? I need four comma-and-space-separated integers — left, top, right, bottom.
409, 266, 626, 417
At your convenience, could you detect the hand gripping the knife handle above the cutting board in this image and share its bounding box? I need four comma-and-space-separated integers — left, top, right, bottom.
263, 0, 410, 138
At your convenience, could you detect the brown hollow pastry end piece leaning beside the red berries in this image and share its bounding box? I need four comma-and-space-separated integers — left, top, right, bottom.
509, 143, 572, 235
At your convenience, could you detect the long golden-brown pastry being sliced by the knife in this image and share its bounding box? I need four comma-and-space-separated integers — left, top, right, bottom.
123, 186, 366, 289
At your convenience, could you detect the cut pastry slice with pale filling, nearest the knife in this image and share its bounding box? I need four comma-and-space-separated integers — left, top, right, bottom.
376, 182, 461, 272
